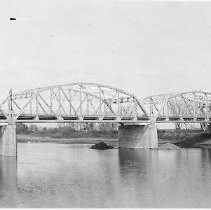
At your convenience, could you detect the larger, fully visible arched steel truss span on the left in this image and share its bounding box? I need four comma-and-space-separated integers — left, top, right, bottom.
0, 83, 149, 122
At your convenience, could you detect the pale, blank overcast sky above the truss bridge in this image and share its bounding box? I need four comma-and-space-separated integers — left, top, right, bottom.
0, 0, 211, 99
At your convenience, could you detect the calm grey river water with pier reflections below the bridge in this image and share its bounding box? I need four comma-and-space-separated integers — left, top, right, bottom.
0, 143, 211, 207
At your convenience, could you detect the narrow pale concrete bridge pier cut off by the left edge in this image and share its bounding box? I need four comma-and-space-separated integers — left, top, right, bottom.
0, 124, 17, 157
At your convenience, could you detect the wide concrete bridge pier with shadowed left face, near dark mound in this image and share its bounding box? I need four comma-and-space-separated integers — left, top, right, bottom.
118, 123, 158, 149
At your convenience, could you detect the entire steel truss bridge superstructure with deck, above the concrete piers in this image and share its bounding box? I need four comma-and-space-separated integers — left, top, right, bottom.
0, 82, 211, 124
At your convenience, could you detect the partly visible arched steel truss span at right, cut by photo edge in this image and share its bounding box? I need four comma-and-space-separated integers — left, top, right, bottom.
140, 91, 211, 122
